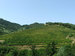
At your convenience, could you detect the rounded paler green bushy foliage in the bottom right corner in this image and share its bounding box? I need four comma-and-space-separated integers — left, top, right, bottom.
57, 45, 75, 56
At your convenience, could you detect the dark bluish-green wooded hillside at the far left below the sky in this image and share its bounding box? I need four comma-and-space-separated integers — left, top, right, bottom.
0, 18, 21, 35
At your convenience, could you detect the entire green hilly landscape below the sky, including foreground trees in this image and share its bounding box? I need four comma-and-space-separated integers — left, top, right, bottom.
0, 19, 75, 56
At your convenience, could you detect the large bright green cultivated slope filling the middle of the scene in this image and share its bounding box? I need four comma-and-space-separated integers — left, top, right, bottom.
0, 25, 75, 46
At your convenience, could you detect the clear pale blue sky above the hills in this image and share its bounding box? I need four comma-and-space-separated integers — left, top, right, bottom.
0, 0, 75, 25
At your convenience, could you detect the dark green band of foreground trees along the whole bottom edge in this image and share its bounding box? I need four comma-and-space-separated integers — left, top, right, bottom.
0, 43, 75, 56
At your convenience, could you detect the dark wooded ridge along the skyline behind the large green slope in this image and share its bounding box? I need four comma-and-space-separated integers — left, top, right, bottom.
22, 22, 75, 30
